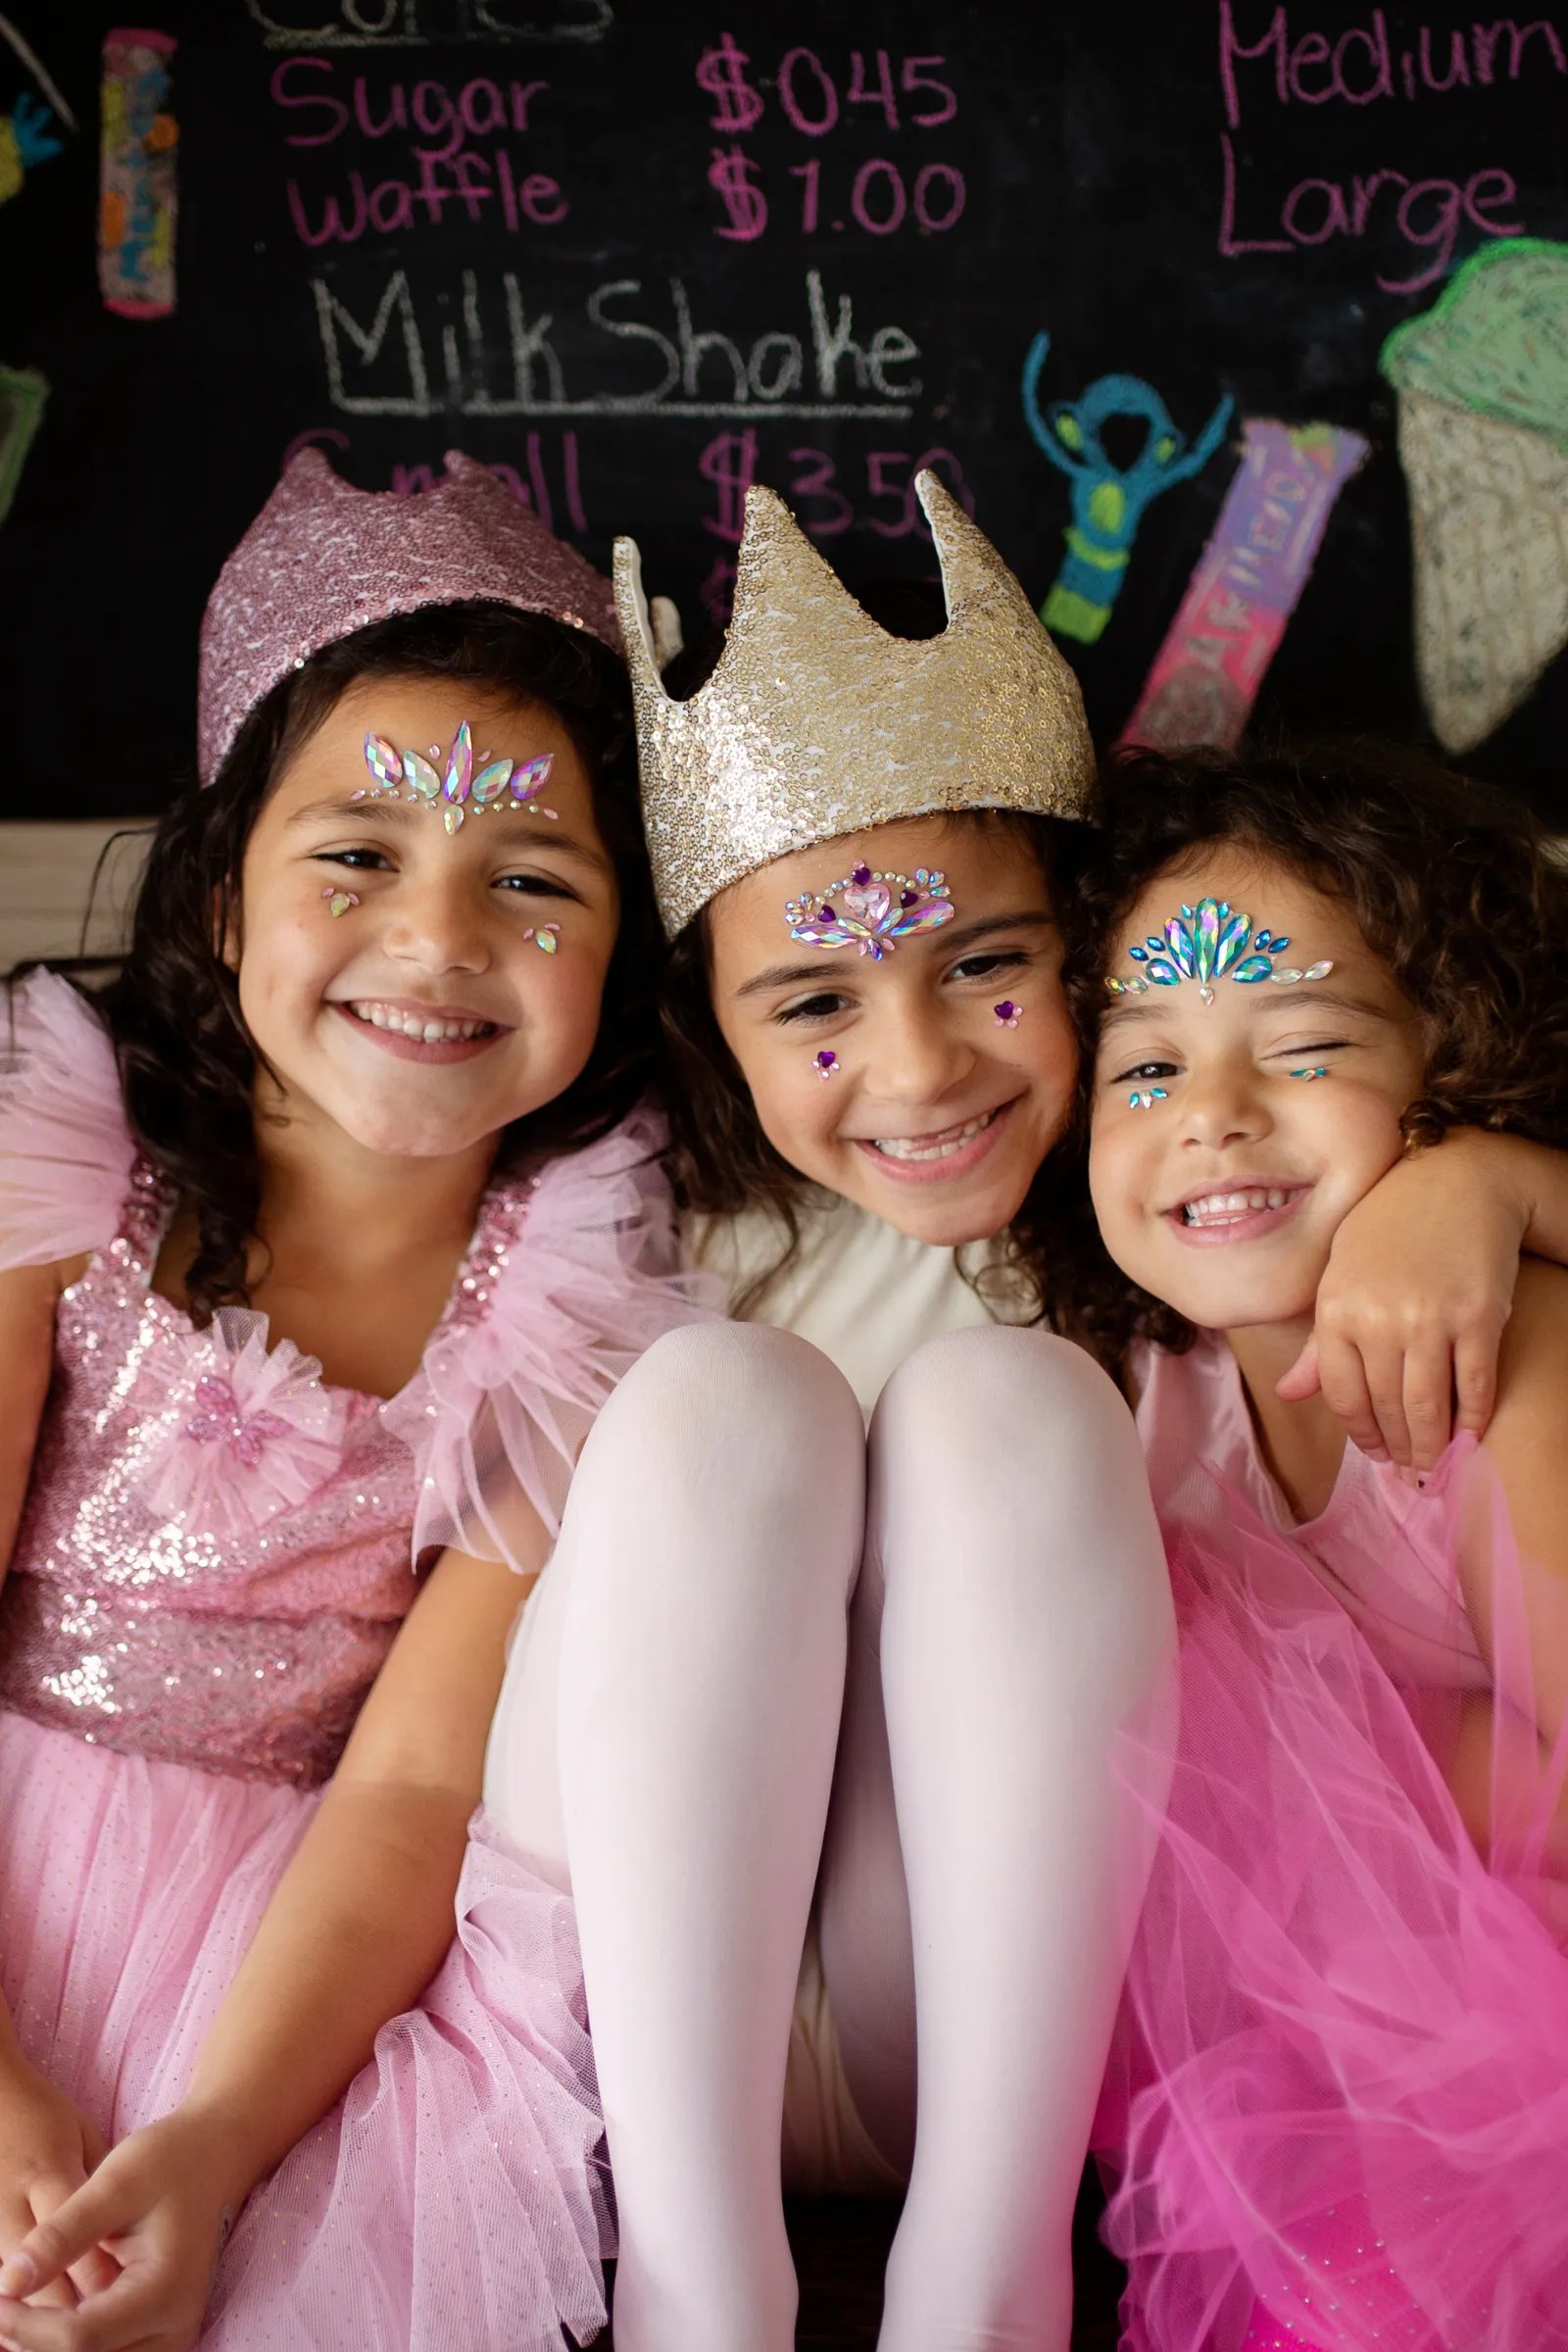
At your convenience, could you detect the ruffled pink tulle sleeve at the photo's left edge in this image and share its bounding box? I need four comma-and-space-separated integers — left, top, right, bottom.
0, 971, 136, 1272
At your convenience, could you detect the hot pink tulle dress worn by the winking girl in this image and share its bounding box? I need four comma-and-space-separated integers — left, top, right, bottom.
1096, 1336, 1568, 2352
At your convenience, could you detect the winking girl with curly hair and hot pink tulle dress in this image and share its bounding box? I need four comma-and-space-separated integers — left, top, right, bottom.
1067, 746, 1568, 2352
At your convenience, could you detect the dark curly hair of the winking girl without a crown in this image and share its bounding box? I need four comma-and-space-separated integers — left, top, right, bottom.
1034, 739, 1568, 1366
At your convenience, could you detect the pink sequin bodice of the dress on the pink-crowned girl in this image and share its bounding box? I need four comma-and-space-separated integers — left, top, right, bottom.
0, 1169, 529, 1786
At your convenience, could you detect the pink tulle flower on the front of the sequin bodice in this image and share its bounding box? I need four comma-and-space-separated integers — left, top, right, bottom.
143, 1307, 346, 1536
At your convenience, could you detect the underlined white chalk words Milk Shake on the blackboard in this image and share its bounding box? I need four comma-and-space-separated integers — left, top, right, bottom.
311, 270, 921, 421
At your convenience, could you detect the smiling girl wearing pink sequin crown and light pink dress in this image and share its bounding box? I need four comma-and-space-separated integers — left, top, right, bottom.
0, 452, 696, 2352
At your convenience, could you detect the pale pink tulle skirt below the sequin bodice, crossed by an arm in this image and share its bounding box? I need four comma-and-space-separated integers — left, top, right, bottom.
0, 1715, 612, 2352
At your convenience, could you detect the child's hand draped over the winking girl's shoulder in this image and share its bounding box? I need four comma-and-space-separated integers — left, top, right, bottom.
1277, 1129, 1531, 1470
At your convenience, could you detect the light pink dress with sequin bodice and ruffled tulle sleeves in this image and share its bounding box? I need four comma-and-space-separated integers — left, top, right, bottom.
0, 976, 691, 2352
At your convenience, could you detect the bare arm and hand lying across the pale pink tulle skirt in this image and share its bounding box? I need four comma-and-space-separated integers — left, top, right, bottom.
0, 1533, 548, 2352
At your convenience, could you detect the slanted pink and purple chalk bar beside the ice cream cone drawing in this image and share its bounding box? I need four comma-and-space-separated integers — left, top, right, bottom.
1121, 416, 1366, 751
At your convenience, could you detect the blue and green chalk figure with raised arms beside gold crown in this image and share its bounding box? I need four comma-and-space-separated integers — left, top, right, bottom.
1022, 334, 1234, 645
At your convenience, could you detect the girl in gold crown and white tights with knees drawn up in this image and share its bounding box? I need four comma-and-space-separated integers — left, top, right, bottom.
472, 475, 1551, 2352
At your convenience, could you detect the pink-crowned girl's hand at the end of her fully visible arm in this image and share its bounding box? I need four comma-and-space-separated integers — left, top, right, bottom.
0, 2110, 230, 2352
